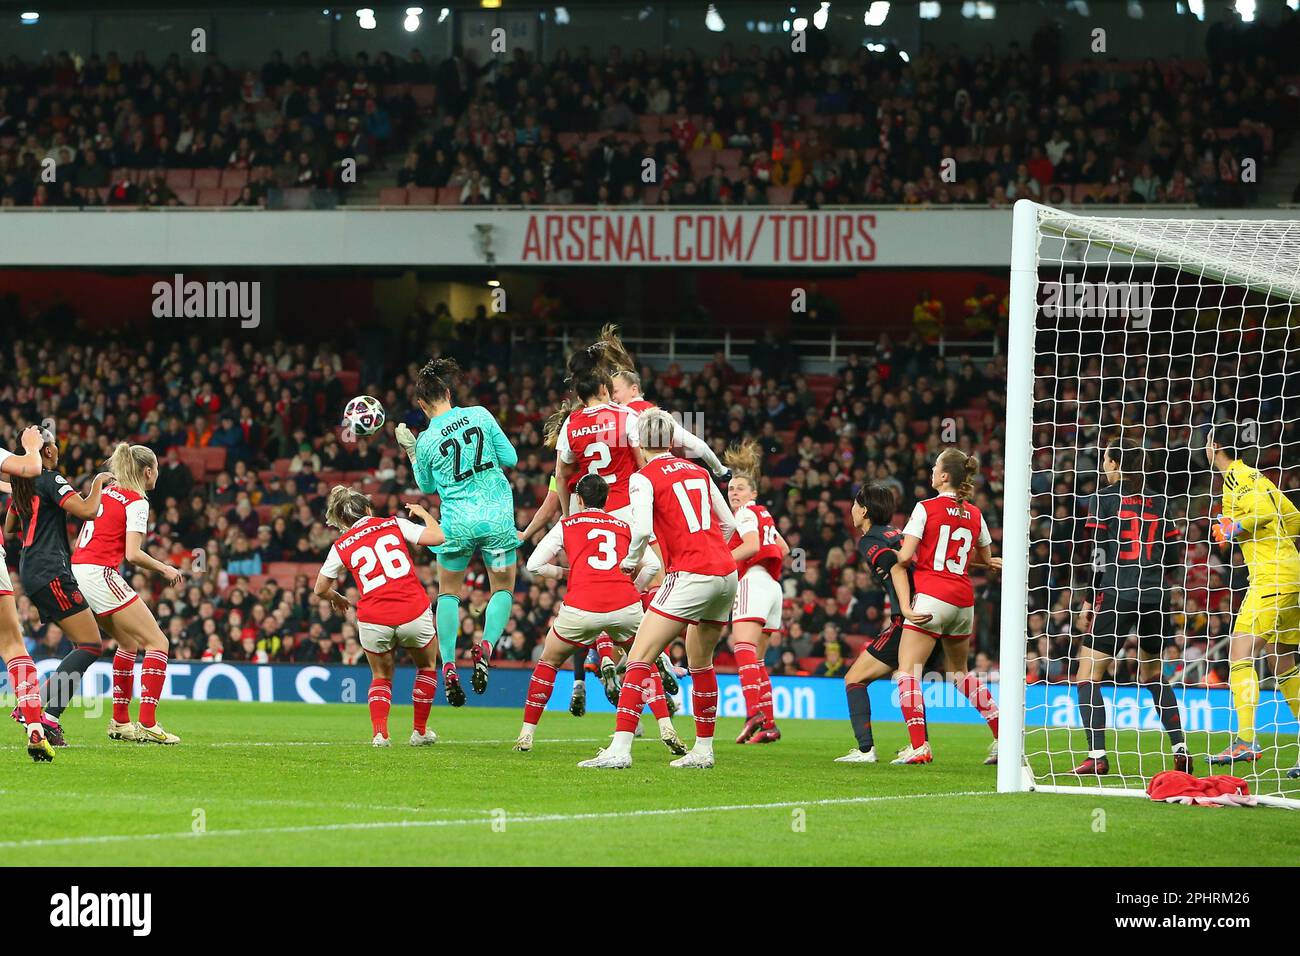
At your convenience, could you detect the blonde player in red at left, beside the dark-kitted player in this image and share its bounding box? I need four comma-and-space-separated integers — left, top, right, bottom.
72, 442, 183, 744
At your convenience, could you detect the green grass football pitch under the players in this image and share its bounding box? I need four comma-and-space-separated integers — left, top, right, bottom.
0, 701, 1300, 868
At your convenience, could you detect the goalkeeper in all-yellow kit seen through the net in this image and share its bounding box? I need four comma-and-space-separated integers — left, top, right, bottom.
1205, 424, 1300, 777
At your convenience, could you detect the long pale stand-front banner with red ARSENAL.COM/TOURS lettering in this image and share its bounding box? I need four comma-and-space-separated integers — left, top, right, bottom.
0, 206, 1275, 271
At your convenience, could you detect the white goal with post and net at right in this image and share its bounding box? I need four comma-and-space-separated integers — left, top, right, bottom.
998, 200, 1300, 809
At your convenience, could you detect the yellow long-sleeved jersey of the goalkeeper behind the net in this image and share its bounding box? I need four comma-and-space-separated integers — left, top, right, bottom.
1223, 460, 1300, 594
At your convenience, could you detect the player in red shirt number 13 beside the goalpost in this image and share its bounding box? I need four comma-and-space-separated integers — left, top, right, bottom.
892, 449, 1002, 763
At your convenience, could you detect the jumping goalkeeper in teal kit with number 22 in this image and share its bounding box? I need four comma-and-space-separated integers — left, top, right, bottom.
397, 359, 519, 708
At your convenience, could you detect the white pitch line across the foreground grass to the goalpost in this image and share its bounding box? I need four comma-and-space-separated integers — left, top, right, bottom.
0, 790, 995, 849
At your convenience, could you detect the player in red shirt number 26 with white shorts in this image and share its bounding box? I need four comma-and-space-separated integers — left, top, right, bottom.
315, 485, 445, 747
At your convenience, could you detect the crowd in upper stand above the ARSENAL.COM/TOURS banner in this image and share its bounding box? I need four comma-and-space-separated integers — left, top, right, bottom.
0, 9, 1300, 208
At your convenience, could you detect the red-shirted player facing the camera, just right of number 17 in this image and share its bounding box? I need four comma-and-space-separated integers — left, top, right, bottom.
723, 441, 790, 744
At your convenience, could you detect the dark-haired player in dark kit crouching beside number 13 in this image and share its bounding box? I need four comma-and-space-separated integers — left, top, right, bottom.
835, 481, 930, 763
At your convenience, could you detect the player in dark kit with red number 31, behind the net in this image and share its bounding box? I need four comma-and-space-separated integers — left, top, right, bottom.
1074, 440, 1192, 775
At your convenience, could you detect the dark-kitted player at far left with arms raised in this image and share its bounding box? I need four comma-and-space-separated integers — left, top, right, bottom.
4, 431, 113, 747
